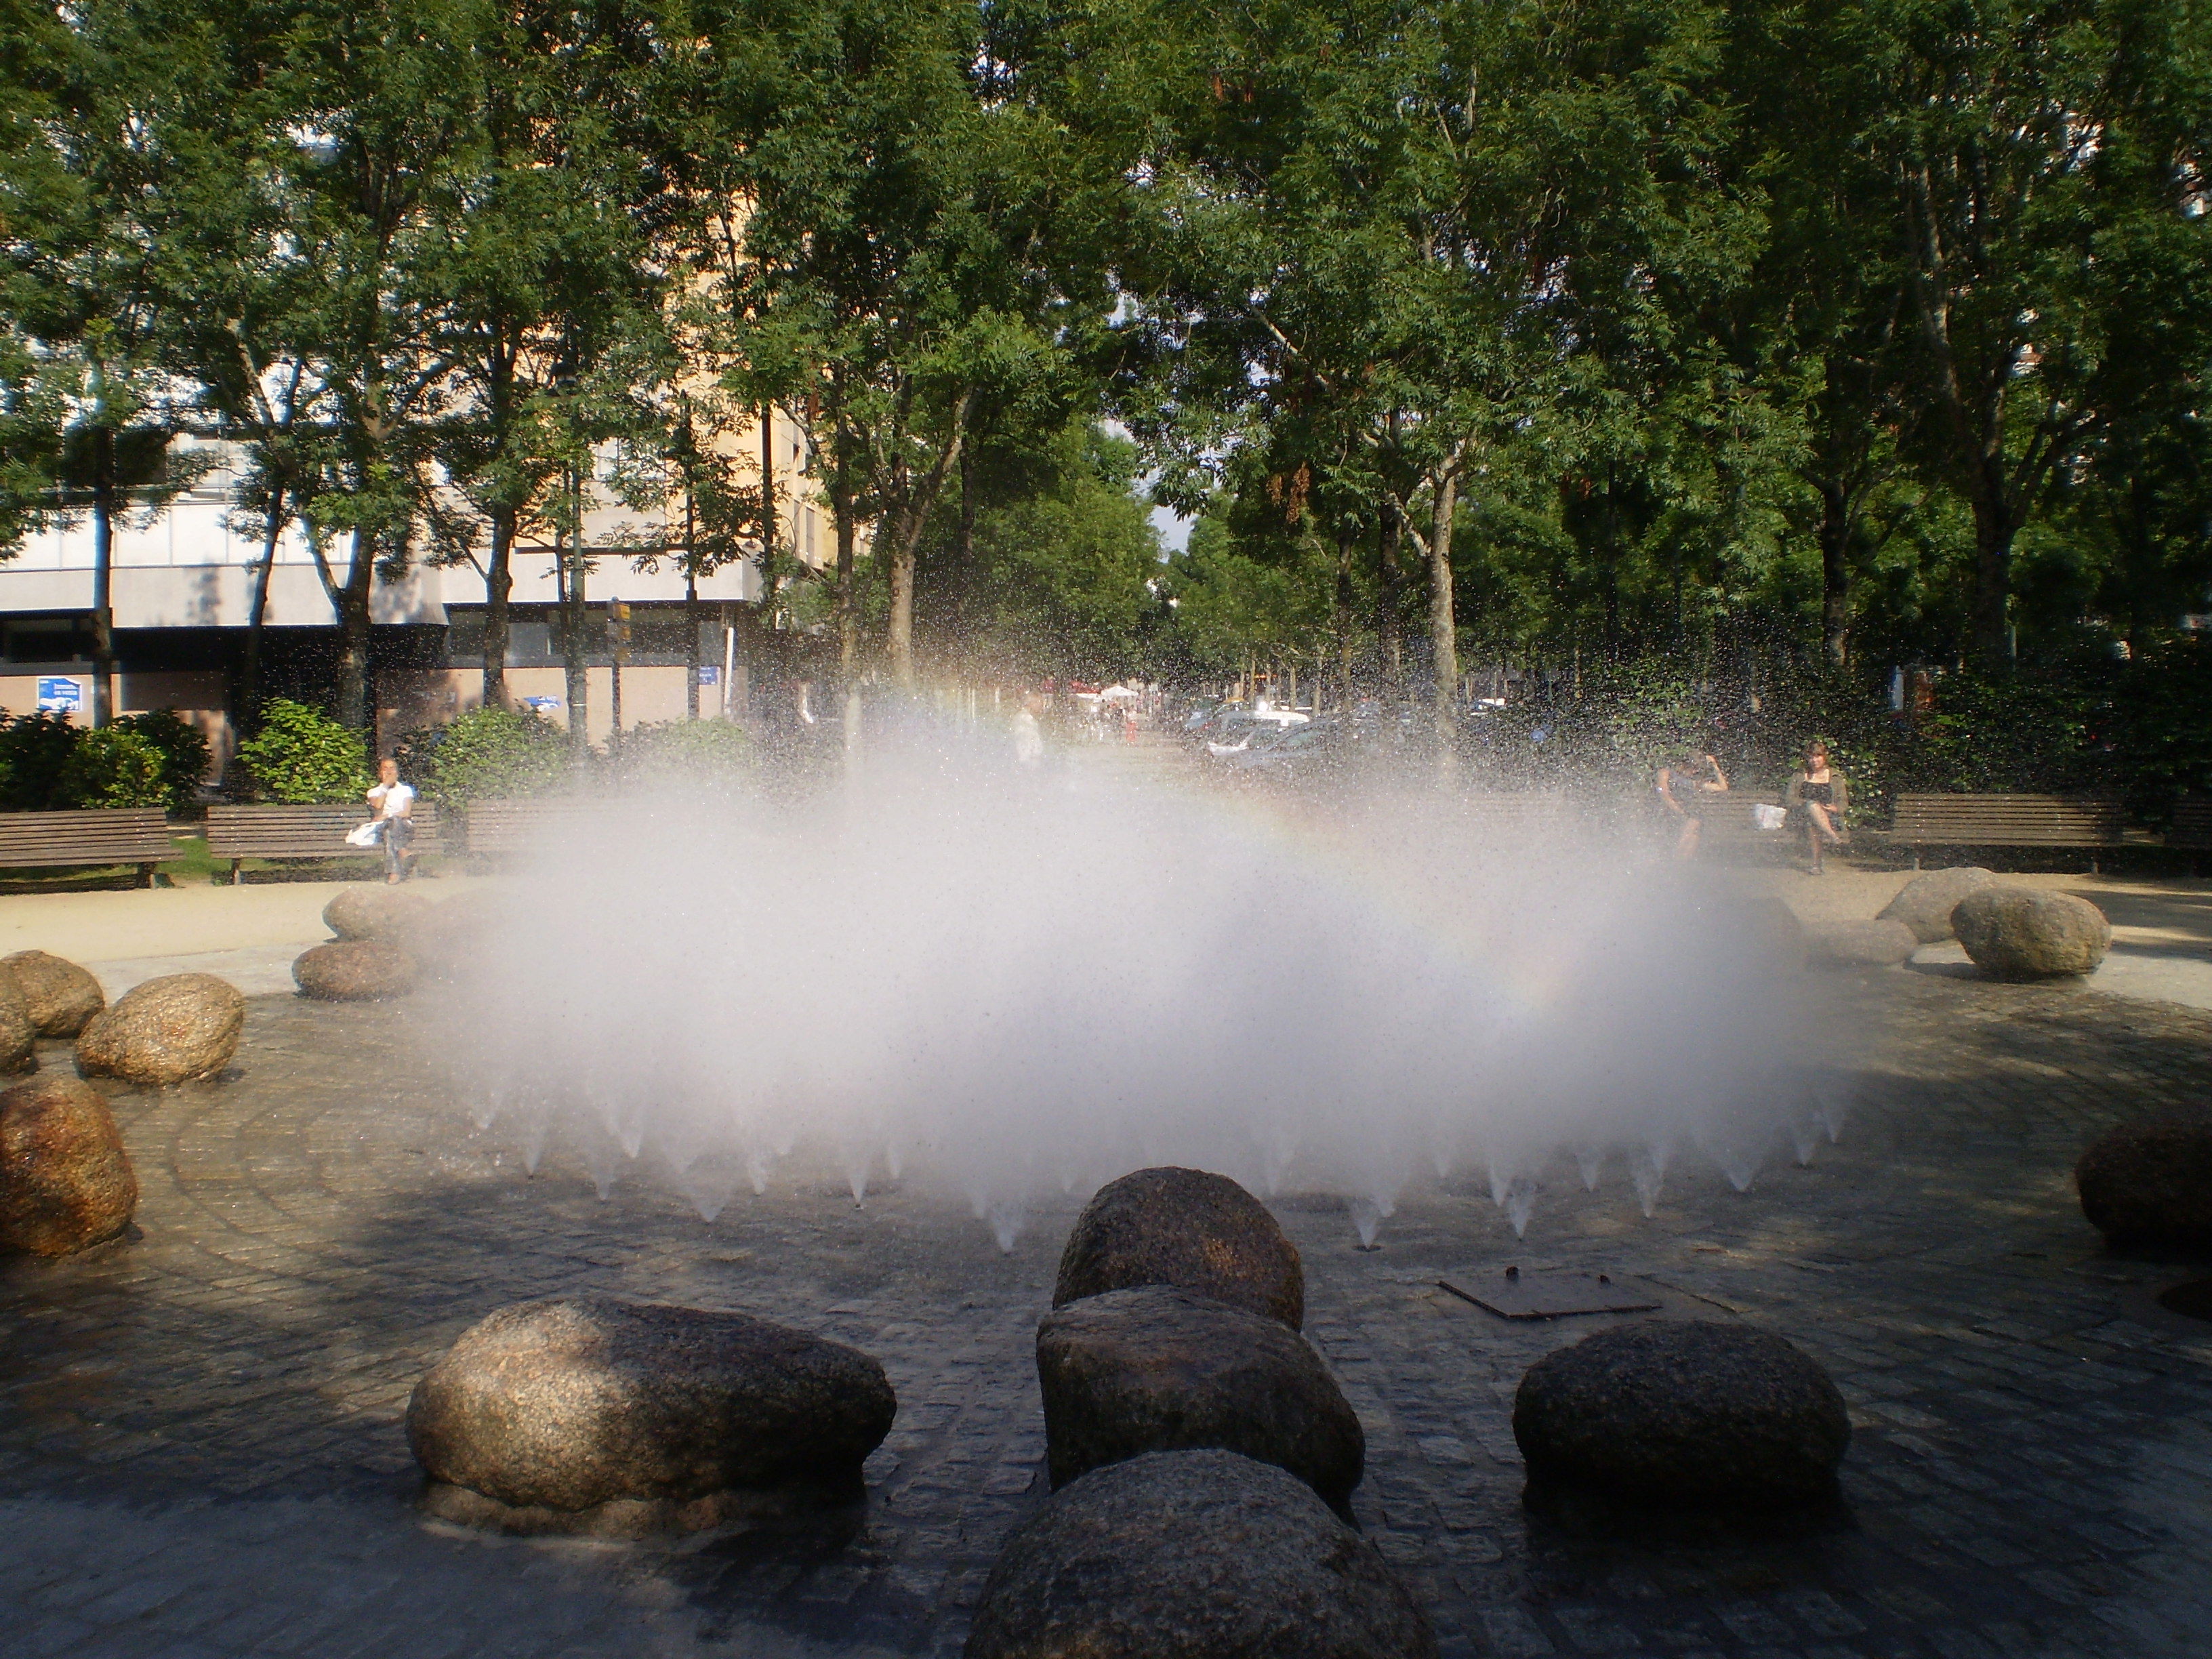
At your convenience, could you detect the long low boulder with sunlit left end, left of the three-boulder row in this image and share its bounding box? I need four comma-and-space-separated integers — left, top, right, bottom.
407, 1296, 898, 1531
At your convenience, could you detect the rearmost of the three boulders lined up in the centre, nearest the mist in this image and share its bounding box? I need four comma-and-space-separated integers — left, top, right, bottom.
1053, 1168, 1305, 1330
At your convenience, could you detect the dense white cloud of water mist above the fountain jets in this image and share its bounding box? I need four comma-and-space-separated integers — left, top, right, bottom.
443, 750, 1841, 1248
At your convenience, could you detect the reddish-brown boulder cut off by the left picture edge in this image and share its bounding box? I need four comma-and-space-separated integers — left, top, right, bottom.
0, 1078, 137, 1256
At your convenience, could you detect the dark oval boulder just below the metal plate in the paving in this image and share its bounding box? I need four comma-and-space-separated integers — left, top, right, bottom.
1513, 1321, 1851, 1509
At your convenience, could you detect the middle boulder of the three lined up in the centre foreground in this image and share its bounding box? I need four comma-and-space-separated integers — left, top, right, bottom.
1038, 1285, 1367, 1509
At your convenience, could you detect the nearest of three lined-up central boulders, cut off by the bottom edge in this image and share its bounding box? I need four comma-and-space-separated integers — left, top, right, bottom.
966, 1451, 1435, 1659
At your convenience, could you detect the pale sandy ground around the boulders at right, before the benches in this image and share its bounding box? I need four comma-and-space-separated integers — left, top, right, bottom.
1743, 863, 2212, 1008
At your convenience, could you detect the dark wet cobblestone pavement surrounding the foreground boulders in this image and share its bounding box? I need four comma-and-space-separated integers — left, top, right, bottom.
0, 973, 2212, 1659
